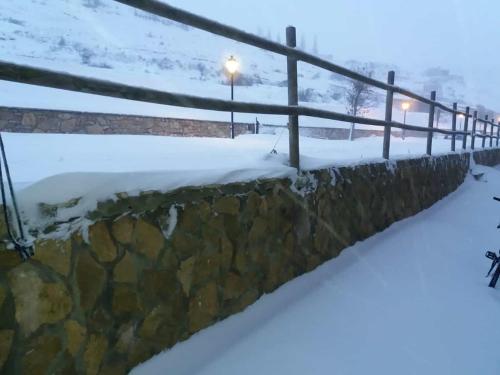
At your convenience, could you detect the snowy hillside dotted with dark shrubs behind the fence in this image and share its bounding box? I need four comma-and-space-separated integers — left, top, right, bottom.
0, 0, 474, 125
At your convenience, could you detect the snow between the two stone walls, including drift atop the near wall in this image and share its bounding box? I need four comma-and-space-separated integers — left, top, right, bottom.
4, 129, 468, 236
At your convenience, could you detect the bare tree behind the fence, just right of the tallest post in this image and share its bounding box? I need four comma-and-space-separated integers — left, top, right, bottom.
344, 65, 377, 141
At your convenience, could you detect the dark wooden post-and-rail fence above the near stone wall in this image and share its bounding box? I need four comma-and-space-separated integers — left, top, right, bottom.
0, 0, 500, 169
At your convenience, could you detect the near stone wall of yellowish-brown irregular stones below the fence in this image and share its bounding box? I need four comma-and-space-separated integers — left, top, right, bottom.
0, 150, 500, 374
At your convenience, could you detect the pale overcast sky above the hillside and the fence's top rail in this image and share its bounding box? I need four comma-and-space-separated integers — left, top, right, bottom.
164, 0, 500, 107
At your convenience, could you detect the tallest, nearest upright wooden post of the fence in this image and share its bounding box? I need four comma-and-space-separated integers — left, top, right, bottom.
286, 26, 300, 169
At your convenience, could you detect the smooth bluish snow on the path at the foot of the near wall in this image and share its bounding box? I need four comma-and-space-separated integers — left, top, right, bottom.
132, 166, 500, 375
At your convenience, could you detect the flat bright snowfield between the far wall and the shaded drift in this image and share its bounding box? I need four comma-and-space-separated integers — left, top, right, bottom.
9, 128, 458, 193
